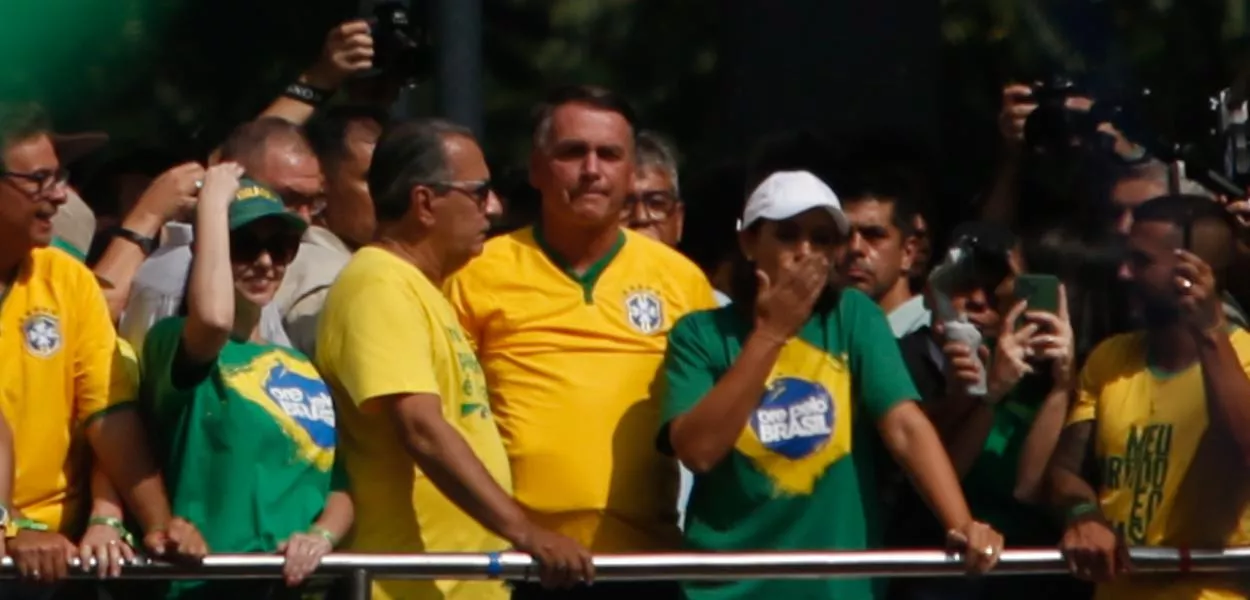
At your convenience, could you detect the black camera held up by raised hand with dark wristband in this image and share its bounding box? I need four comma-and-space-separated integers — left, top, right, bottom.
368, 0, 433, 86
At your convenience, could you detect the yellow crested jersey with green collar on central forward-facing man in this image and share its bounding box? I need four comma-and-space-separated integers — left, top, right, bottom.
446, 229, 716, 551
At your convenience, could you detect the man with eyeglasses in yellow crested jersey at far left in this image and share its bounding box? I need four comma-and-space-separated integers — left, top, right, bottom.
0, 104, 205, 598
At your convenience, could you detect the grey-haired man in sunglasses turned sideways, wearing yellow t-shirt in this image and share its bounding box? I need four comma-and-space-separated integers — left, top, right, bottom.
316, 120, 593, 600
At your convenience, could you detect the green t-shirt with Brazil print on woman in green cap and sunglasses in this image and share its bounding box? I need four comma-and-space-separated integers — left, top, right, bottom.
140, 318, 344, 595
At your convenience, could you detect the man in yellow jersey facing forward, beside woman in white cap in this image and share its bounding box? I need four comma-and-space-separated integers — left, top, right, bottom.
448, 88, 716, 600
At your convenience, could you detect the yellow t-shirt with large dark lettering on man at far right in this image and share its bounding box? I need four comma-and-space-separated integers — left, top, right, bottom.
1069, 329, 1250, 600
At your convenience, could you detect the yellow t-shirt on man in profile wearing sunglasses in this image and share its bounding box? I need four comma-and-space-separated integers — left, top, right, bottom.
316, 248, 513, 600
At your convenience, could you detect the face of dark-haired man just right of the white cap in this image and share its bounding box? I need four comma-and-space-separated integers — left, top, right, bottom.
838, 199, 915, 300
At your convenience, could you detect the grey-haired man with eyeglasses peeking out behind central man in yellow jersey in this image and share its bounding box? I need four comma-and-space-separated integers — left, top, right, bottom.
621, 130, 686, 248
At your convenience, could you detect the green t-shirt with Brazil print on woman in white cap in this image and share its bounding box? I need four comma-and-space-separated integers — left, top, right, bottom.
660, 290, 918, 600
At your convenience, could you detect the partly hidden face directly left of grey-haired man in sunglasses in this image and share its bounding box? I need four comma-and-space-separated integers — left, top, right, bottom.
325, 119, 383, 248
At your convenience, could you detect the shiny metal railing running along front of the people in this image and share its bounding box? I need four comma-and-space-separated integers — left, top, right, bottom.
0, 548, 1250, 600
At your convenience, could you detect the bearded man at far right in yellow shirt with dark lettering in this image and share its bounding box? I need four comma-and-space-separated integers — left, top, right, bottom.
1050, 195, 1250, 600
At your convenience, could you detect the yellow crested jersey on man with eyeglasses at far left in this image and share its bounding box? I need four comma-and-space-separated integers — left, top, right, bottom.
0, 249, 134, 535
